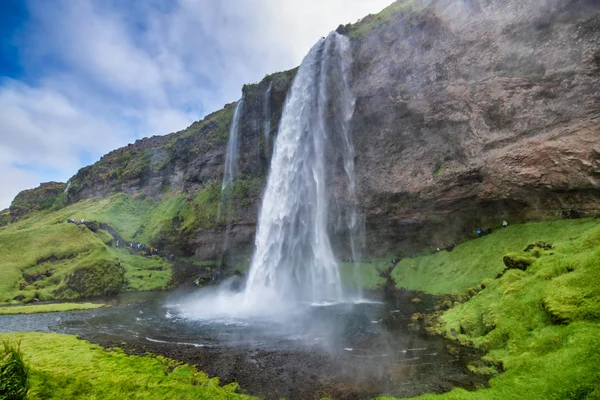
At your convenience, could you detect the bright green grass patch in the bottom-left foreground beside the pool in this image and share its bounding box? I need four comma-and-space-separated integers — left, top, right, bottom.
0, 333, 250, 400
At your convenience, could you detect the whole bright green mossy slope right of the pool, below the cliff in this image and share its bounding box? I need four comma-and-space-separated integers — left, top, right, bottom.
376, 220, 600, 399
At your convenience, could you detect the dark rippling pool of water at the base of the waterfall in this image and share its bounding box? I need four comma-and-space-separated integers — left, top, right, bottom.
0, 292, 482, 399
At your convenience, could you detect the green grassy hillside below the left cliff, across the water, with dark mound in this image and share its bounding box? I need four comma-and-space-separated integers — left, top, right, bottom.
0, 194, 179, 303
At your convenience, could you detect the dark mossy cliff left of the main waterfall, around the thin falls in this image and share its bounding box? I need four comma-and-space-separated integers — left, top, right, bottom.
68, 70, 295, 202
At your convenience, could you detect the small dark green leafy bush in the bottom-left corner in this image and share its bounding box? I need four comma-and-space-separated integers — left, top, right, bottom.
0, 342, 29, 400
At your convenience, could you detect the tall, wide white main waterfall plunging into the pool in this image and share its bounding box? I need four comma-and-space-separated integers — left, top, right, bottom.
245, 32, 356, 302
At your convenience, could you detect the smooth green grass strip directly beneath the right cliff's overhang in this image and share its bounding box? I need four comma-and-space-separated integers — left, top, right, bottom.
342, 219, 600, 294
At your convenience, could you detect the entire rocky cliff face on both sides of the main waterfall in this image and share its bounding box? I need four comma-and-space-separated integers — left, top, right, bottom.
8, 0, 600, 259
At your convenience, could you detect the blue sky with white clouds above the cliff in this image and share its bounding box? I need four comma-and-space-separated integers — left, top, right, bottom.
0, 0, 392, 209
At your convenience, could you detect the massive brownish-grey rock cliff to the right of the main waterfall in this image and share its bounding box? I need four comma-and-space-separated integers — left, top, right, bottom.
338, 0, 600, 252
